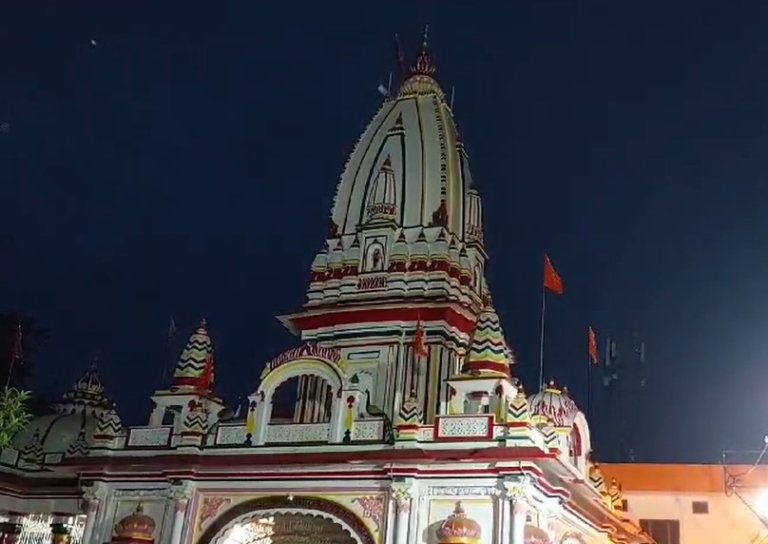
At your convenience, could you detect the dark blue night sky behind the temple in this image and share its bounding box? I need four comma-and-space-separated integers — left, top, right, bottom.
0, 0, 768, 461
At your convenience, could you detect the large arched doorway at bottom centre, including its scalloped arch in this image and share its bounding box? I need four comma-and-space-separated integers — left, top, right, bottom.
198, 497, 375, 544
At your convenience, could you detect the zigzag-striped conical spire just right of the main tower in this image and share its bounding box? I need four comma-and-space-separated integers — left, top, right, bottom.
462, 305, 513, 376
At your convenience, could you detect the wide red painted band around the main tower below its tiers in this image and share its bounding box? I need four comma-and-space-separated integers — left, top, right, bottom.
287, 305, 475, 334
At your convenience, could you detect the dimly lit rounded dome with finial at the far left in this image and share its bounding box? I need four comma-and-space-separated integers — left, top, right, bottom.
13, 365, 119, 462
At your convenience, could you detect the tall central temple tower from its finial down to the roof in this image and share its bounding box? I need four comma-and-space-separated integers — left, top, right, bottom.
280, 37, 500, 422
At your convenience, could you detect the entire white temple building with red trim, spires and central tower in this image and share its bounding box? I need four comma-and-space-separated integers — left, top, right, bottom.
0, 36, 653, 544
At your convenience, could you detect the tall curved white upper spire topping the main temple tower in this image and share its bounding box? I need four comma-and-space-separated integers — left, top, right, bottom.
332, 36, 472, 239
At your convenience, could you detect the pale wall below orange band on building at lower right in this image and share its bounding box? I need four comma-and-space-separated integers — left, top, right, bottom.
623, 491, 768, 544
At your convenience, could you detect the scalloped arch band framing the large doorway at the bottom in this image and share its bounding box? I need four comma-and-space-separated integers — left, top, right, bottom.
197, 496, 375, 544
